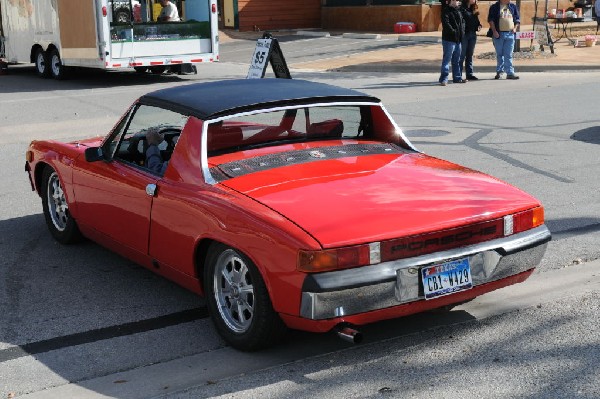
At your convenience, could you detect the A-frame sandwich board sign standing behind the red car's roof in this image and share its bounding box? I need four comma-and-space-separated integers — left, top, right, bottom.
246, 33, 292, 79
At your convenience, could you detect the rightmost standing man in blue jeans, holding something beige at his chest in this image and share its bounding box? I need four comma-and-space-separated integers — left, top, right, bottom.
488, 0, 520, 79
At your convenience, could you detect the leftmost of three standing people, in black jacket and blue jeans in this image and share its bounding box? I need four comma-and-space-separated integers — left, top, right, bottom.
439, 0, 467, 86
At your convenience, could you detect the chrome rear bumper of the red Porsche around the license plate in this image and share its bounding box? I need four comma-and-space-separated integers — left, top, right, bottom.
300, 225, 551, 320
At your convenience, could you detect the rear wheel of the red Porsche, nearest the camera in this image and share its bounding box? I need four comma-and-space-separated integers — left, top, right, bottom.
204, 243, 287, 351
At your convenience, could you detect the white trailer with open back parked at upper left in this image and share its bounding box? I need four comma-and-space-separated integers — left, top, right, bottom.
0, 0, 219, 79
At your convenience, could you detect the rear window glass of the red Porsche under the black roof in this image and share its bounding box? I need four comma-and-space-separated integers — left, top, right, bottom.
207, 104, 398, 156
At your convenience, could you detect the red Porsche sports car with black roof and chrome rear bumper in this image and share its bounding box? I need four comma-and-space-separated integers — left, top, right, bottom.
25, 79, 551, 350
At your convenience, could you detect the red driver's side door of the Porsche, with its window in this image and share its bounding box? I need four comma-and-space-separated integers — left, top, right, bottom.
73, 105, 186, 254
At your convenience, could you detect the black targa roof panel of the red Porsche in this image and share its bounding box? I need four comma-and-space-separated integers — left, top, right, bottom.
140, 79, 380, 120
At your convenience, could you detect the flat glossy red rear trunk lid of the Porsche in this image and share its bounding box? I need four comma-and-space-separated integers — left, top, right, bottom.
222, 153, 539, 248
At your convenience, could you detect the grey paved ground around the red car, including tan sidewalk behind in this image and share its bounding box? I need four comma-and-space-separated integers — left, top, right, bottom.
0, 26, 600, 399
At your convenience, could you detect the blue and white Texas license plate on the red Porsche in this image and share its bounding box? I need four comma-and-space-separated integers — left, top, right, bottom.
421, 258, 473, 299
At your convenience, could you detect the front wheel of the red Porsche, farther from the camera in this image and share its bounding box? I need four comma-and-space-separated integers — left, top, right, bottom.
42, 166, 82, 244
